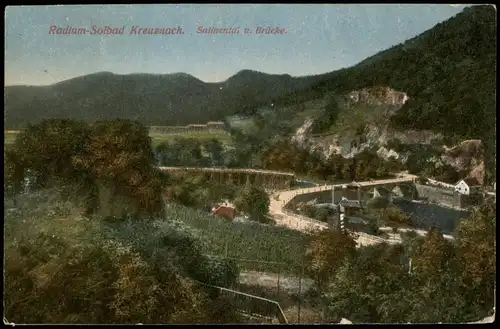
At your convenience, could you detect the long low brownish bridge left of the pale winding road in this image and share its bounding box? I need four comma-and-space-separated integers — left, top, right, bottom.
159, 167, 295, 190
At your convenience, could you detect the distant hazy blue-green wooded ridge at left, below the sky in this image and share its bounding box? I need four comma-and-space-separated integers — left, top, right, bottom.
4, 70, 328, 129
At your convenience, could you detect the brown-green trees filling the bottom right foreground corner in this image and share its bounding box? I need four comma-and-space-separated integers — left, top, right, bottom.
307, 205, 496, 323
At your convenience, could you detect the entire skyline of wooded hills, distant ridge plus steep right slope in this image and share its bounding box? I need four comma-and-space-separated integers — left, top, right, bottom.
4, 5, 496, 154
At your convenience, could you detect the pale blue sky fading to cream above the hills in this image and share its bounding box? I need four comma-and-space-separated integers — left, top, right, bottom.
5, 4, 465, 85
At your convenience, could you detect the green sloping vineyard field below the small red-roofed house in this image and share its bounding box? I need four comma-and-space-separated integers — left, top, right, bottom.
166, 205, 309, 273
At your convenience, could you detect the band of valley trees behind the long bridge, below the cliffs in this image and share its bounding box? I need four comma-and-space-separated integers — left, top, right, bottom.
155, 113, 410, 186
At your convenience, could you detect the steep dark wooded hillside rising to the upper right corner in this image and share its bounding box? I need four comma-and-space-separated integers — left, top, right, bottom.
268, 5, 497, 176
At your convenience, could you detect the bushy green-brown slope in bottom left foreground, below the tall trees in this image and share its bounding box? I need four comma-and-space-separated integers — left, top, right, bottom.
4, 190, 240, 324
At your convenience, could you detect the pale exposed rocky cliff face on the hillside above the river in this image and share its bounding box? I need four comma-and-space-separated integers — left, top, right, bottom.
292, 87, 484, 182
